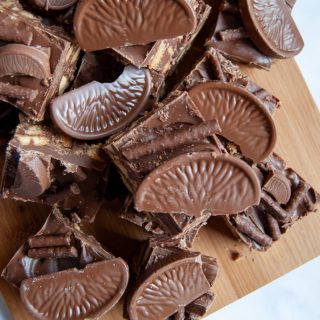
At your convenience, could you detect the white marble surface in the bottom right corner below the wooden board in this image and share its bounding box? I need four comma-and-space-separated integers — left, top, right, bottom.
206, 257, 320, 320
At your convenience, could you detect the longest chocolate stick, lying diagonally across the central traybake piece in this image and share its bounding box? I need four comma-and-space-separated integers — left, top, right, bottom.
122, 120, 221, 160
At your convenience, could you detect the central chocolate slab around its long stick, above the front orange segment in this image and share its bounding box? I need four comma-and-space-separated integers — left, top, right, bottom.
105, 92, 223, 191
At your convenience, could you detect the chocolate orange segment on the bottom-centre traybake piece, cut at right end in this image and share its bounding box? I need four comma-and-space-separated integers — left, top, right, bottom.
128, 256, 210, 320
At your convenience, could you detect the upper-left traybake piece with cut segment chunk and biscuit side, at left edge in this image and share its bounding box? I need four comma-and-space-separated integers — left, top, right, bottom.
0, 0, 80, 121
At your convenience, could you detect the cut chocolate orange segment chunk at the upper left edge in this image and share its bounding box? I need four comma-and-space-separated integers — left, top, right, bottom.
0, 44, 51, 79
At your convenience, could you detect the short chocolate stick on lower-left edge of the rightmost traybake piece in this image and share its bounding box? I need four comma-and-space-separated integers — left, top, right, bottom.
234, 215, 272, 247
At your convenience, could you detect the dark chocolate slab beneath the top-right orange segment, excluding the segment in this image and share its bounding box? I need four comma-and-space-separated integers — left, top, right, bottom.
205, 0, 272, 70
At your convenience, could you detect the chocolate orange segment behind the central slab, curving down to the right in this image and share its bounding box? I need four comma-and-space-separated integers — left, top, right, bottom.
189, 81, 277, 162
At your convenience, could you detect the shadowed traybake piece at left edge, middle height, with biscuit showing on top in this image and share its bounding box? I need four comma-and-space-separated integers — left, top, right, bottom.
1, 122, 108, 222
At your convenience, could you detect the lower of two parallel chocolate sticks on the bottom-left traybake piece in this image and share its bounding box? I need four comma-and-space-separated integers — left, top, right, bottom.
28, 247, 78, 259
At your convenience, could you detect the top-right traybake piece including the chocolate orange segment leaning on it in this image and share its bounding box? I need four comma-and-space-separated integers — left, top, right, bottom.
206, 0, 303, 70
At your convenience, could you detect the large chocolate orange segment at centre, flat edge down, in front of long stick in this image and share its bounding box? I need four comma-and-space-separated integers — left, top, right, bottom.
135, 152, 261, 216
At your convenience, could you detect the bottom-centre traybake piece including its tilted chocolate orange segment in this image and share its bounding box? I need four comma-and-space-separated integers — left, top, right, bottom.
125, 247, 218, 320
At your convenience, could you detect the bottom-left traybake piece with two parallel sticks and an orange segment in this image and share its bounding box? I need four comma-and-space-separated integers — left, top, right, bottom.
2, 208, 129, 320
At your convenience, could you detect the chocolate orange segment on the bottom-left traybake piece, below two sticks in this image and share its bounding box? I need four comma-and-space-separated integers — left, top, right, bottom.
20, 258, 129, 320
